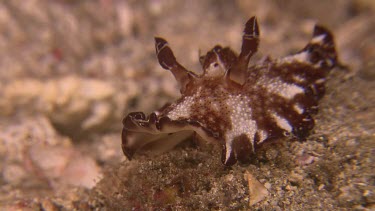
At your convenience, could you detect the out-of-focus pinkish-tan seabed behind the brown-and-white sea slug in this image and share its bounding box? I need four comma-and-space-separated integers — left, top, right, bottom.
0, 0, 375, 210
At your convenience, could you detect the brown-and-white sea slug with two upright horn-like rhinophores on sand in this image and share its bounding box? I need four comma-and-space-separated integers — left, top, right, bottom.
122, 17, 337, 165
